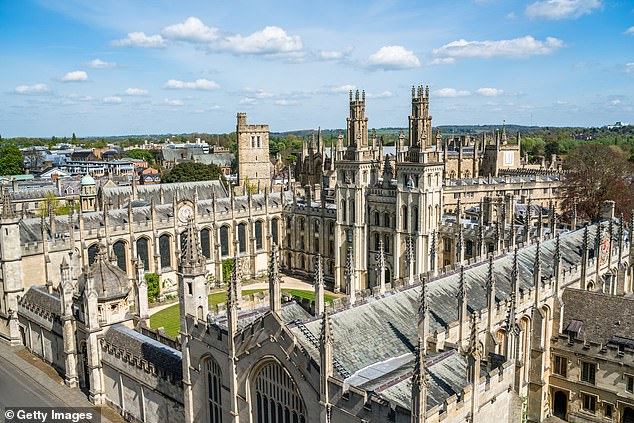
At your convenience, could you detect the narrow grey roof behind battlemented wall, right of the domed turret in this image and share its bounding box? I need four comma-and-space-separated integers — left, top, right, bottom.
104, 324, 183, 381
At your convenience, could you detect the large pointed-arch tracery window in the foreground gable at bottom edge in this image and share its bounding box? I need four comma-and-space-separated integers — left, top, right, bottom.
254, 362, 306, 423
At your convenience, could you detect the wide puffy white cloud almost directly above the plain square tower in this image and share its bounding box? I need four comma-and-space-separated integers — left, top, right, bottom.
221, 26, 303, 55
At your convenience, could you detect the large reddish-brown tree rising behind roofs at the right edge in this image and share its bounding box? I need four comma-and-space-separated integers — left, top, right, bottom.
562, 144, 634, 220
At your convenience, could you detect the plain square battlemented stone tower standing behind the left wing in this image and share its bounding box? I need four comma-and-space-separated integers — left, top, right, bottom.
236, 112, 271, 187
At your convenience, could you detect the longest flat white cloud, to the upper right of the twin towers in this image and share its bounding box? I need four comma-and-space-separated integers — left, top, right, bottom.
434, 35, 564, 59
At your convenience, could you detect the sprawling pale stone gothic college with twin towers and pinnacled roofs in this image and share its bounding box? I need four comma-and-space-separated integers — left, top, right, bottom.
0, 87, 634, 423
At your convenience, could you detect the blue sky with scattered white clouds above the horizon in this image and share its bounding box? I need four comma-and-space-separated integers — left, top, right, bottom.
0, 0, 634, 138
